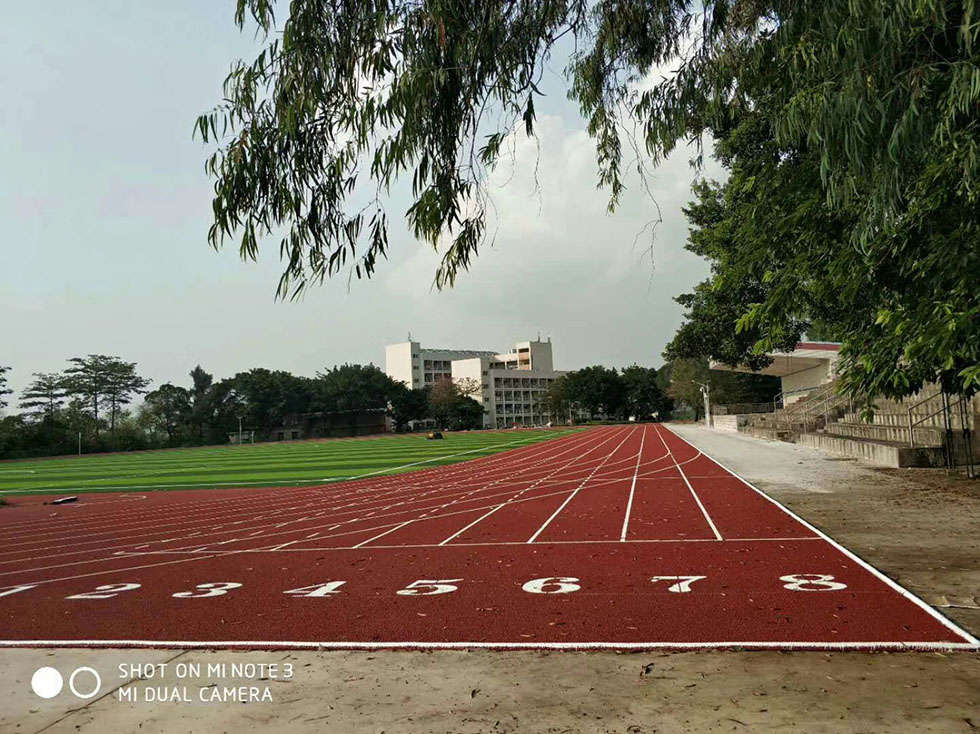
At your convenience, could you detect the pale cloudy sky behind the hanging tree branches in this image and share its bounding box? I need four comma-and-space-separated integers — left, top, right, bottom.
0, 0, 721, 412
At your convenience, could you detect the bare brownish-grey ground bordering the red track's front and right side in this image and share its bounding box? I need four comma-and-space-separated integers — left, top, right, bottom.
0, 426, 980, 734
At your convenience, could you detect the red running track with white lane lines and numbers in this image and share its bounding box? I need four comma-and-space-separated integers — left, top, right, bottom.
0, 424, 978, 649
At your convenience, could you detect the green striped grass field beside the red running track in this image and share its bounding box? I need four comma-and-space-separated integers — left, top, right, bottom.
0, 429, 575, 497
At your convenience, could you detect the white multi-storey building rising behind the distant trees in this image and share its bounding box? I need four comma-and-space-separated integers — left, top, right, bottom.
385, 339, 565, 428
